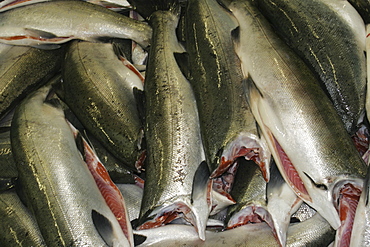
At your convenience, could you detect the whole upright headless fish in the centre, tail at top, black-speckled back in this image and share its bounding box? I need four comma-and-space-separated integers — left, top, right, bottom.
140, 3, 209, 238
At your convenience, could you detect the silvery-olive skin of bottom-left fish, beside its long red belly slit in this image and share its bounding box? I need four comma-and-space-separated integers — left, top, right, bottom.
11, 86, 129, 246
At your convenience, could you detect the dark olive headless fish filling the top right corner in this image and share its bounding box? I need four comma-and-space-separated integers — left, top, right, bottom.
256, 0, 366, 135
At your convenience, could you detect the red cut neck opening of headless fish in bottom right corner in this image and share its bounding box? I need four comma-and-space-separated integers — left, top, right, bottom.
333, 181, 362, 247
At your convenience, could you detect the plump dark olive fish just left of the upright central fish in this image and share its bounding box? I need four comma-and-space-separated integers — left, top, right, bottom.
62, 41, 143, 170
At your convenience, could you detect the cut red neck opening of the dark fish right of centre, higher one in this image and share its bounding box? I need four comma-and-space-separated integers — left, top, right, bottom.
210, 133, 271, 182
